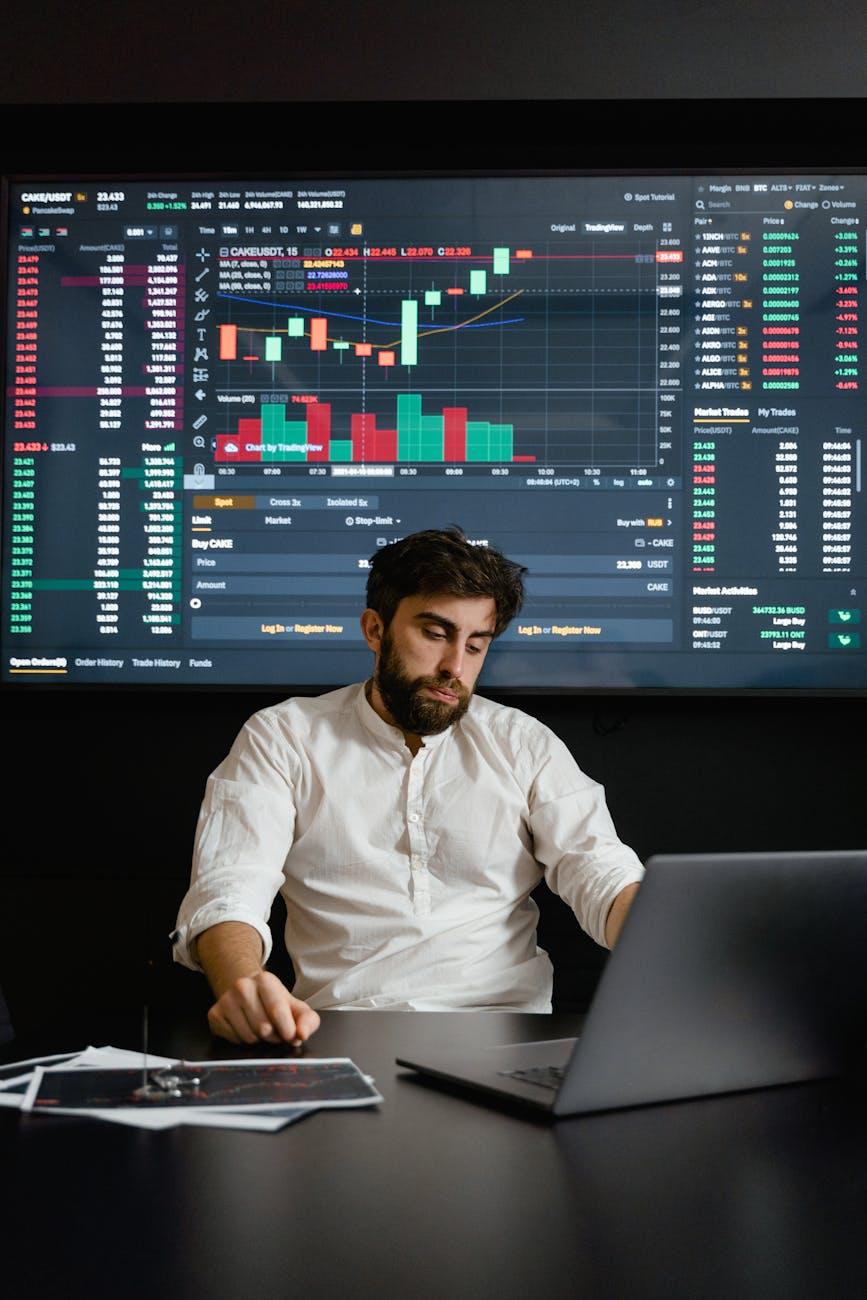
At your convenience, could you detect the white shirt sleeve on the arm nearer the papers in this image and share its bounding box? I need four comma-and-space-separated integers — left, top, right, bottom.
172, 714, 299, 970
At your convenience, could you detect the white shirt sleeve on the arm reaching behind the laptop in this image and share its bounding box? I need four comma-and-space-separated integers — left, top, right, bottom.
528, 728, 645, 948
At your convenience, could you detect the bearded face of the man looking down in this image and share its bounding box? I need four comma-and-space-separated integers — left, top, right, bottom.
368, 595, 497, 736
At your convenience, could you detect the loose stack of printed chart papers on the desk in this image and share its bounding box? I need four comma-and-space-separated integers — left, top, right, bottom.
0, 1047, 382, 1132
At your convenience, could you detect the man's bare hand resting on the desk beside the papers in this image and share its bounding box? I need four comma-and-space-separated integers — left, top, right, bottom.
208, 970, 320, 1044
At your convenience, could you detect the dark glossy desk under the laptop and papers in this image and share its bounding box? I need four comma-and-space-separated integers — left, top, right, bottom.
0, 1011, 867, 1300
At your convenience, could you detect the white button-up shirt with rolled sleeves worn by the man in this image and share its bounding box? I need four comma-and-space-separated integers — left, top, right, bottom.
173, 685, 643, 1011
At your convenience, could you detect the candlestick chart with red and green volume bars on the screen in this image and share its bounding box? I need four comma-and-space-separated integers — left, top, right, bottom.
213, 239, 659, 467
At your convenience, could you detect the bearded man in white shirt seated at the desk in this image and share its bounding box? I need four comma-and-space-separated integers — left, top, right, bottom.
173, 529, 643, 1043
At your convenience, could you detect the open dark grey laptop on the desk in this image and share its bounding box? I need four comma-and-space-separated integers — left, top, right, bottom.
396, 852, 867, 1117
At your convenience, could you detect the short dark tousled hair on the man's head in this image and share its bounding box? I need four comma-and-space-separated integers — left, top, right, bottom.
368, 527, 526, 637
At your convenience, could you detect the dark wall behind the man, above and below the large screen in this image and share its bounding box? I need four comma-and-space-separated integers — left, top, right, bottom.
0, 0, 867, 1027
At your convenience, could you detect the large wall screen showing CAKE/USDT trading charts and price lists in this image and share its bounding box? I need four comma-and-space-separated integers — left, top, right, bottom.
3, 174, 867, 690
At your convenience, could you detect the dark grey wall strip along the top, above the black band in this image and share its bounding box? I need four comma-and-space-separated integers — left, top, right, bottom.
0, 0, 867, 102
